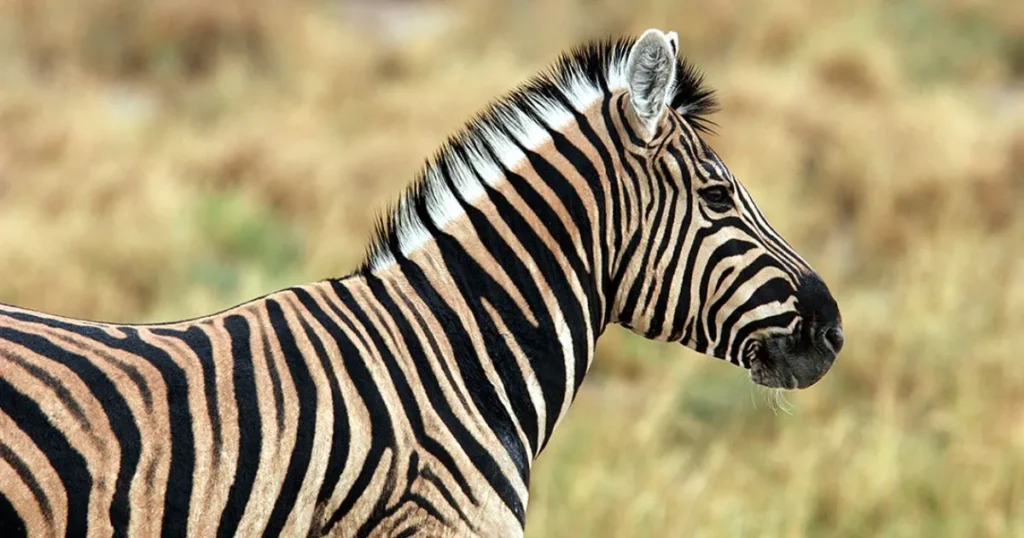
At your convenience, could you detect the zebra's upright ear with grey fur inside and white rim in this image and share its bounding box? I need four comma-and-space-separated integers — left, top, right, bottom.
626, 29, 679, 136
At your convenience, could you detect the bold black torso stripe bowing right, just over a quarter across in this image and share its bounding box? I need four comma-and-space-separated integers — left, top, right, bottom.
263, 299, 316, 536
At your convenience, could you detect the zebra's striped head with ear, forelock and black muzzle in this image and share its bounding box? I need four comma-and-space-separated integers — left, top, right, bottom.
613, 30, 843, 389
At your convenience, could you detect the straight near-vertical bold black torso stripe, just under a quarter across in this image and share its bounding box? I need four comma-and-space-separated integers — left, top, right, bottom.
217, 316, 263, 538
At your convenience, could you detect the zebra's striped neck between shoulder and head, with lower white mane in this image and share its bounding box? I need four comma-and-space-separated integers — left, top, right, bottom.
344, 93, 637, 465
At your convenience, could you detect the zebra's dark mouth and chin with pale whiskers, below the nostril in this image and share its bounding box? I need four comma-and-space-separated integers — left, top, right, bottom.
743, 333, 836, 390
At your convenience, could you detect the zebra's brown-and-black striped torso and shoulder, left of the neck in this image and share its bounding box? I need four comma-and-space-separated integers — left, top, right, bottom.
0, 278, 525, 536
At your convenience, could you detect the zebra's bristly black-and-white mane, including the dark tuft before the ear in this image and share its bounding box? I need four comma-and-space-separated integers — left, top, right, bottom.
358, 37, 718, 273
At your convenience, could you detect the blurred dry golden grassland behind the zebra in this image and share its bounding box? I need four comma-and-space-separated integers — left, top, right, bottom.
0, 0, 1024, 537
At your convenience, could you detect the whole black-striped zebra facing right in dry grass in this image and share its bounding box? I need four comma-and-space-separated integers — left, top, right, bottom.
0, 29, 844, 536
